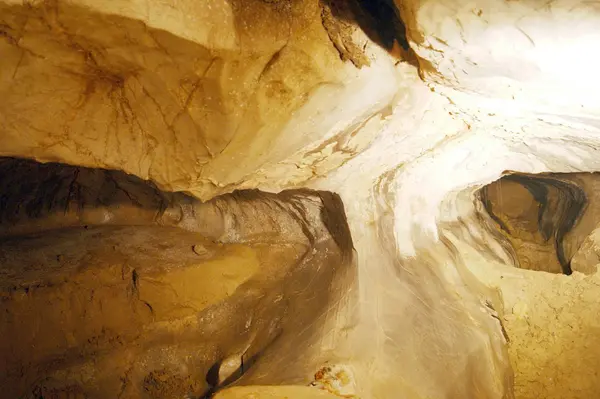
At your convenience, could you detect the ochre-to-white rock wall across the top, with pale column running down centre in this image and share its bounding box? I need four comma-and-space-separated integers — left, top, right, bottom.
0, 0, 600, 398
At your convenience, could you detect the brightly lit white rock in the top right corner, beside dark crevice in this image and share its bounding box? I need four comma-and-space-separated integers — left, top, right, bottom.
395, 0, 600, 116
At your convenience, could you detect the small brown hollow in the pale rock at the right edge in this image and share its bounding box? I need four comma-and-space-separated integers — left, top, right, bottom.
479, 173, 600, 275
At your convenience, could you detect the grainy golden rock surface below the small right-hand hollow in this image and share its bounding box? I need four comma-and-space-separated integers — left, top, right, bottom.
459, 241, 600, 399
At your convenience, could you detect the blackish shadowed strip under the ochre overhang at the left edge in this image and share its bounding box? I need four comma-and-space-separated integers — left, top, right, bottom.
0, 158, 177, 225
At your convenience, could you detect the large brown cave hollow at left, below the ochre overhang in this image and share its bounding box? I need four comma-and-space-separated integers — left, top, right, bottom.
0, 158, 354, 398
